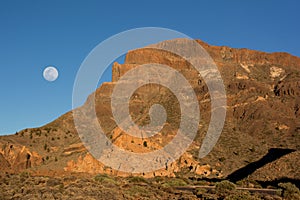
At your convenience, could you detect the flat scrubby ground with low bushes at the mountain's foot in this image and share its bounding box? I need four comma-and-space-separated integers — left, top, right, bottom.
0, 172, 300, 200
